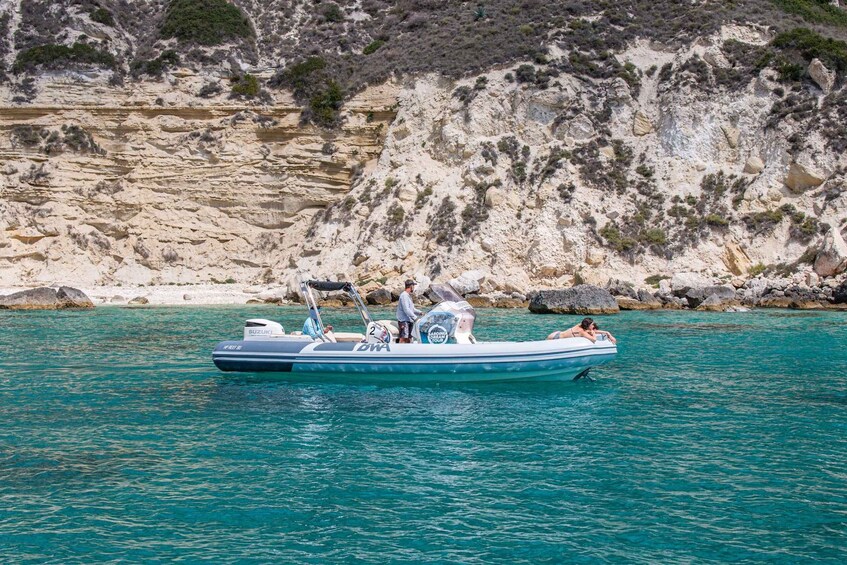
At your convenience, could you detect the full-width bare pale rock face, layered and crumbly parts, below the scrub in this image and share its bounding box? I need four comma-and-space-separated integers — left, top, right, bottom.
0, 15, 847, 298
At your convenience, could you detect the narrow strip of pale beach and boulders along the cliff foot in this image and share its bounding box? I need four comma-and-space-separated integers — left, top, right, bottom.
6, 270, 847, 315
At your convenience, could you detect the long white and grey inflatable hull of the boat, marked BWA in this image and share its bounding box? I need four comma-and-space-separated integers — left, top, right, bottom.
212, 338, 617, 382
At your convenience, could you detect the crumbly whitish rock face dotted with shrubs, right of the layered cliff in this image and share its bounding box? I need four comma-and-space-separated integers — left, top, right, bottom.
288, 26, 847, 298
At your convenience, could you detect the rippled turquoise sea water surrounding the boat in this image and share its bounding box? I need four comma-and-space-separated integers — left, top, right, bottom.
0, 307, 847, 563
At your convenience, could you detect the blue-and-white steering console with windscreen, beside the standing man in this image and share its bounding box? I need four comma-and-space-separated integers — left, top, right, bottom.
412, 284, 476, 344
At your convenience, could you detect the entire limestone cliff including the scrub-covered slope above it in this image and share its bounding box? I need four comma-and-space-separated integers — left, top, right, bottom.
0, 0, 847, 292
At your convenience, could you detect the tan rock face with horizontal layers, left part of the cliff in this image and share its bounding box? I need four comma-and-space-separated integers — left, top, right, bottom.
0, 71, 396, 285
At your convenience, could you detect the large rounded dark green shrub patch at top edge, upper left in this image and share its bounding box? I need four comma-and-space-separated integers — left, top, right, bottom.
160, 0, 253, 45
